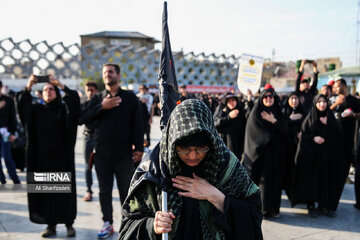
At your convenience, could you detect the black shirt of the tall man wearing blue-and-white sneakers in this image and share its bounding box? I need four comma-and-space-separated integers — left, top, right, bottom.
82, 88, 144, 160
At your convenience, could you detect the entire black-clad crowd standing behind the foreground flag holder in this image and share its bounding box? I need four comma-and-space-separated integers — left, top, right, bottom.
0, 60, 360, 237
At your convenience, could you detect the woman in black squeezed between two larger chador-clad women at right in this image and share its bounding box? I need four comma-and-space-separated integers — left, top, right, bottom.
283, 92, 305, 196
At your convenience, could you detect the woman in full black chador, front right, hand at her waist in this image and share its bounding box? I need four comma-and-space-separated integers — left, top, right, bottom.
290, 95, 346, 217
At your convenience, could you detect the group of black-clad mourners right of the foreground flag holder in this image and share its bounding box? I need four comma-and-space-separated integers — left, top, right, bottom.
194, 60, 360, 218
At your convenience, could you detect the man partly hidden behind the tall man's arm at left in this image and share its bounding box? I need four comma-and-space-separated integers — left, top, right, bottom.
79, 81, 98, 201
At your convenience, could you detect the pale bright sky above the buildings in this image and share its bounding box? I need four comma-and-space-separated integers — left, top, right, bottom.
0, 0, 358, 66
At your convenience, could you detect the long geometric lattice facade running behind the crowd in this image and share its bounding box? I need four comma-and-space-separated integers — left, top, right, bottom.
0, 38, 240, 86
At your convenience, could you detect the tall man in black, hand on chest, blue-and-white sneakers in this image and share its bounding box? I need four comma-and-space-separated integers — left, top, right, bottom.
82, 64, 144, 238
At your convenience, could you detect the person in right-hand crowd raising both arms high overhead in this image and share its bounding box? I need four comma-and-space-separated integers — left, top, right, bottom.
295, 60, 319, 113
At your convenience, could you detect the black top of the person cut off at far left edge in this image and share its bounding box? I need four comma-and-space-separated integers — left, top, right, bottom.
0, 94, 16, 135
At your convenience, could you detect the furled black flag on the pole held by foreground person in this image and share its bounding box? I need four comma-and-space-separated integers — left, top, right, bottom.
158, 2, 179, 130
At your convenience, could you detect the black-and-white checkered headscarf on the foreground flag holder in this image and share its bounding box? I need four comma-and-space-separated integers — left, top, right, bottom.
160, 99, 257, 239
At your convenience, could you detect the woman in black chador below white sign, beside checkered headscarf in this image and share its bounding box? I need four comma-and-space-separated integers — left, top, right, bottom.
214, 93, 246, 159
